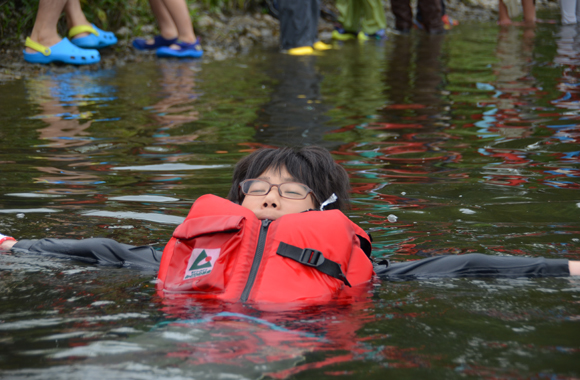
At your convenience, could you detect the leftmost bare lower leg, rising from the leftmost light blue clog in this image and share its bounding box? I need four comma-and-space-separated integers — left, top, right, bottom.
26, 0, 67, 53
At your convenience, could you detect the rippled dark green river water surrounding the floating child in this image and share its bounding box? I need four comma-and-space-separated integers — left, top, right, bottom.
0, 15, 580, 379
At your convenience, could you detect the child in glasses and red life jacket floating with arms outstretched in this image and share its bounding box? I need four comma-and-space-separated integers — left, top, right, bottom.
0, 146, 580, 302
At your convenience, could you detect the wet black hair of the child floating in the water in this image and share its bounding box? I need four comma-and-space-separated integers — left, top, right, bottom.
228, 146, 350, 211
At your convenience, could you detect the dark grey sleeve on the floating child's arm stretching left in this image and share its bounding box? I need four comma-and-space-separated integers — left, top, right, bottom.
12, 238, 162, 270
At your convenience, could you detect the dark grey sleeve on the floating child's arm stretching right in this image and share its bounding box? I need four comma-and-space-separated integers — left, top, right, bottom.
374, 253, 570, 281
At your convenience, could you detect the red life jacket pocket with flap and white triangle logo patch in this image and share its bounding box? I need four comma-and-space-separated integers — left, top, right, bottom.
164, 215, 246, 294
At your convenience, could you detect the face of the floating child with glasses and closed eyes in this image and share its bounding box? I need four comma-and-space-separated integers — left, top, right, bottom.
242, 168, 314, 220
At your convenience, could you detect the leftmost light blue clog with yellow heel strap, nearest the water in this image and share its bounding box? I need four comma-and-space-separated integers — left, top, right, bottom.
23, 37, 101, 65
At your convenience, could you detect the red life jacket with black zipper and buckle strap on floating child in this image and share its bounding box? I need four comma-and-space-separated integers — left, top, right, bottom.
157, 195, 373, 303
